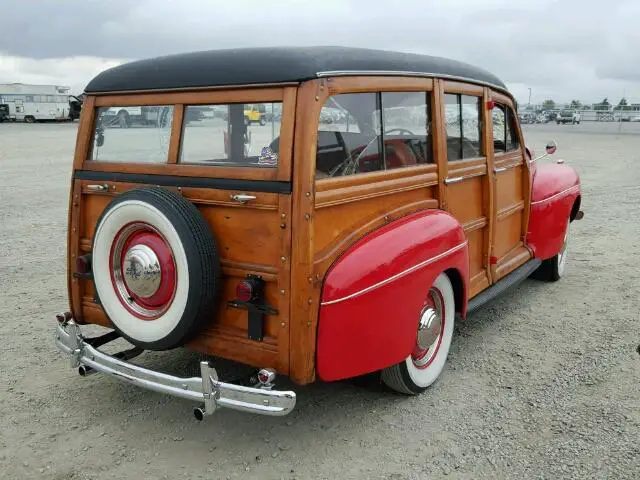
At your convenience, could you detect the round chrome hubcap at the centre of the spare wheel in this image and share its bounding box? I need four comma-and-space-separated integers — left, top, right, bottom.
123, 245, 162, 298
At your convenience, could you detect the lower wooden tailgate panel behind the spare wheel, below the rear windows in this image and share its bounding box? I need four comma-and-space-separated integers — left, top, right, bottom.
73, 180, 291, 373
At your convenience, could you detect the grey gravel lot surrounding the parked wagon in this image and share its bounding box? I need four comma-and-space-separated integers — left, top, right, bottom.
0, 123, 640, 480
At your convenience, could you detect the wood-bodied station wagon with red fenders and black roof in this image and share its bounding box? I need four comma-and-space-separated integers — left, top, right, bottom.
56, 47, 583, 419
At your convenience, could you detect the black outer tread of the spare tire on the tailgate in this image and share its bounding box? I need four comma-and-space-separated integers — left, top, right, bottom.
94, 187, 221, 350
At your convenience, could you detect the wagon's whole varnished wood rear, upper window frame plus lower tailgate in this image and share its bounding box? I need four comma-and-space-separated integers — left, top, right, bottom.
69, 86, 297, 374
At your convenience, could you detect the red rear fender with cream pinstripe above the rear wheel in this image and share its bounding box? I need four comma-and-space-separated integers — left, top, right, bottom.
316, 210, 469, 380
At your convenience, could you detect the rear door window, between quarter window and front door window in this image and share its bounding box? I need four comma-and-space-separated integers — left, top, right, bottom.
445, 93, 482, 162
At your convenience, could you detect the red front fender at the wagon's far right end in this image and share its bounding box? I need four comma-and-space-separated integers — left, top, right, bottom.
527, 164, 581, 260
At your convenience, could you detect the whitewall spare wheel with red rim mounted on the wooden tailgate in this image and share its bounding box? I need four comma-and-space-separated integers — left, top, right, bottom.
92, 187, 220, 350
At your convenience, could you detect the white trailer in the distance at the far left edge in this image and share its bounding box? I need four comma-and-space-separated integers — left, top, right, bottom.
0, 83, 70, 123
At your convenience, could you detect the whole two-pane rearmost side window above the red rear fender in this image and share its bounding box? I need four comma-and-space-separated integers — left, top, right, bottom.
316, 92, 433, 179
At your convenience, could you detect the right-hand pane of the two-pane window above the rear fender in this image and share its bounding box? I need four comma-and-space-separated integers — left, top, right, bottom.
382, 92, 433, 170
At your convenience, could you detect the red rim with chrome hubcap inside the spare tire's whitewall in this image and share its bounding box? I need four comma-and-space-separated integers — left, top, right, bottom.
109, 223, 176, 320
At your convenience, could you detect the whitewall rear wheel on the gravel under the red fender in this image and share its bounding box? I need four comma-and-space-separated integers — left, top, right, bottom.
382, 273, 455, 395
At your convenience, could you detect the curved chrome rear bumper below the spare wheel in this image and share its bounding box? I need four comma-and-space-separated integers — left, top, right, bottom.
56, 316, 296, 420
